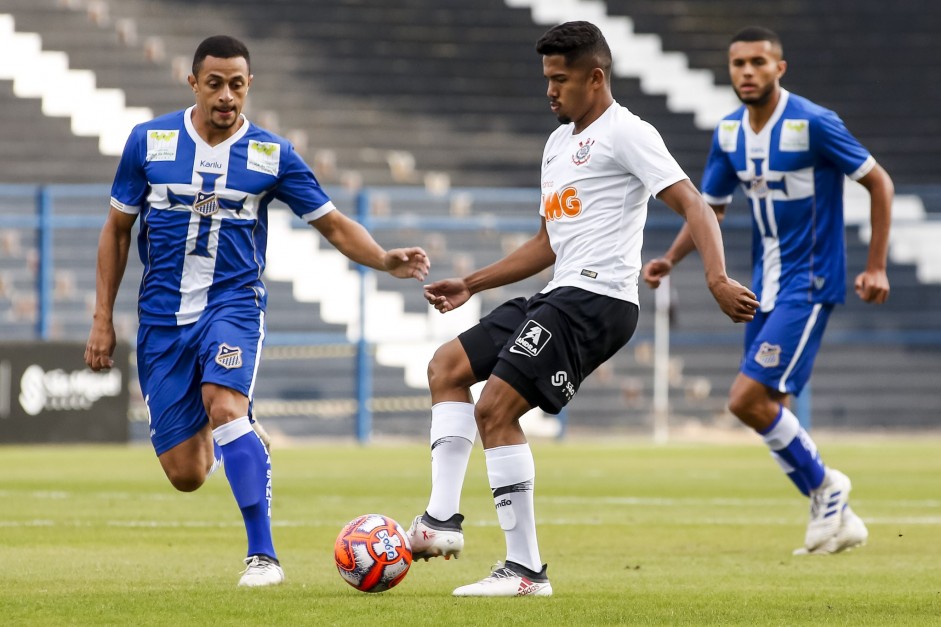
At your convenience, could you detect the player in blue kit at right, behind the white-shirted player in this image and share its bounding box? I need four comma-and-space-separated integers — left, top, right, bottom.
643, 27, 893, 554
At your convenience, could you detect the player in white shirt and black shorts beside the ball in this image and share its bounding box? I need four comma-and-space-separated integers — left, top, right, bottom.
409, 22, 758, 596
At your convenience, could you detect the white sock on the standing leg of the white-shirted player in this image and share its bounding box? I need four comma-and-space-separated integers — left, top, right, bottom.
484, 444, 542, 572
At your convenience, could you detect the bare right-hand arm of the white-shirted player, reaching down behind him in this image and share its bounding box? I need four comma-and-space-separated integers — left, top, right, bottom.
659, 179, 759, 322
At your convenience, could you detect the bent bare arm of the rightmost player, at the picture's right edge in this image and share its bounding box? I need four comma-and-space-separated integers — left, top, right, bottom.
854, 163, 895, 305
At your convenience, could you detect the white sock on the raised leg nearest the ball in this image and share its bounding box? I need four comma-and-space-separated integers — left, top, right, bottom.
426, 401, 477, 520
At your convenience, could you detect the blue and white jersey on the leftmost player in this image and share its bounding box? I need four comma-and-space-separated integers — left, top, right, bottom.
111, 107, 334, 325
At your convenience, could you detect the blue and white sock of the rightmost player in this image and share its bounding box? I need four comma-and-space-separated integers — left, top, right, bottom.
759, 405, 826, 496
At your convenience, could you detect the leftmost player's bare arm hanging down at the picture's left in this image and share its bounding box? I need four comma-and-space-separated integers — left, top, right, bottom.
85, 207, 137, 372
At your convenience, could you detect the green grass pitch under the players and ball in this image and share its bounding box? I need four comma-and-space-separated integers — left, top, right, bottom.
0, 438, 941, 626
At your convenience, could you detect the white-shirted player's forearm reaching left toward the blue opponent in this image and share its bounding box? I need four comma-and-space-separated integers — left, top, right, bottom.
425, 219, 555, 313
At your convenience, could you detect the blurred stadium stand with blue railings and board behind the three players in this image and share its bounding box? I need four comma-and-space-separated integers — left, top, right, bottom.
0, 0, 941, 443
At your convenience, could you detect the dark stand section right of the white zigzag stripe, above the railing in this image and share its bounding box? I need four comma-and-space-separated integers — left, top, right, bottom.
607, 0, 941, 185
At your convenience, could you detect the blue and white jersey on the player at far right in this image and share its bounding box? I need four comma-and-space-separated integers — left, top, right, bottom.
702, 89, 875, 311
